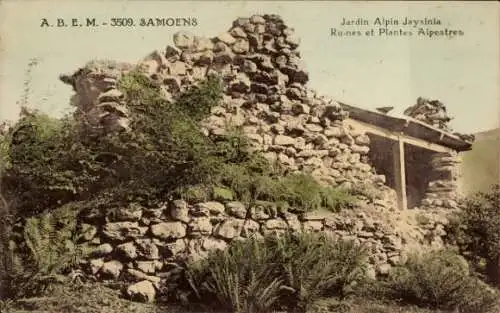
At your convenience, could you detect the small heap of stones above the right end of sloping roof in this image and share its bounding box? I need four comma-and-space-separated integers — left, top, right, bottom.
404, 97, 452, 132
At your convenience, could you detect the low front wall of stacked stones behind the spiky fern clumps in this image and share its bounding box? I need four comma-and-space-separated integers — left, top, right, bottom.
80, 200, 420, 301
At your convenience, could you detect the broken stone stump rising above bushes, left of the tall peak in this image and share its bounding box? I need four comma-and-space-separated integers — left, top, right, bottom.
60, 61, 131, 132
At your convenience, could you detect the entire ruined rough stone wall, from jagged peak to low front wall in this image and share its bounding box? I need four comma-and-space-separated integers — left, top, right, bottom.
61, 15, 460, 296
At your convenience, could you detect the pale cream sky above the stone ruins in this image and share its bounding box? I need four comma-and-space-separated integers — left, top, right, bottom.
0, 0, 500, 133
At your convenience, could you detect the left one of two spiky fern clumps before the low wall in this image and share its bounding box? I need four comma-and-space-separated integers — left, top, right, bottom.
187, 239, 283, 313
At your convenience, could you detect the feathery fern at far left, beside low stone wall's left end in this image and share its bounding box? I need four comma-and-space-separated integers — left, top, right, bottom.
2, 205, 81, 298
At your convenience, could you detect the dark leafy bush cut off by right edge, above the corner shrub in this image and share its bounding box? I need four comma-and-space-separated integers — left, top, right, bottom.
447, 185, 500, 287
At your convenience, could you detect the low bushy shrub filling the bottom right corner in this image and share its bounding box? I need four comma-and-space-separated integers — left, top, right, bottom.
378, 250, 499, 313
